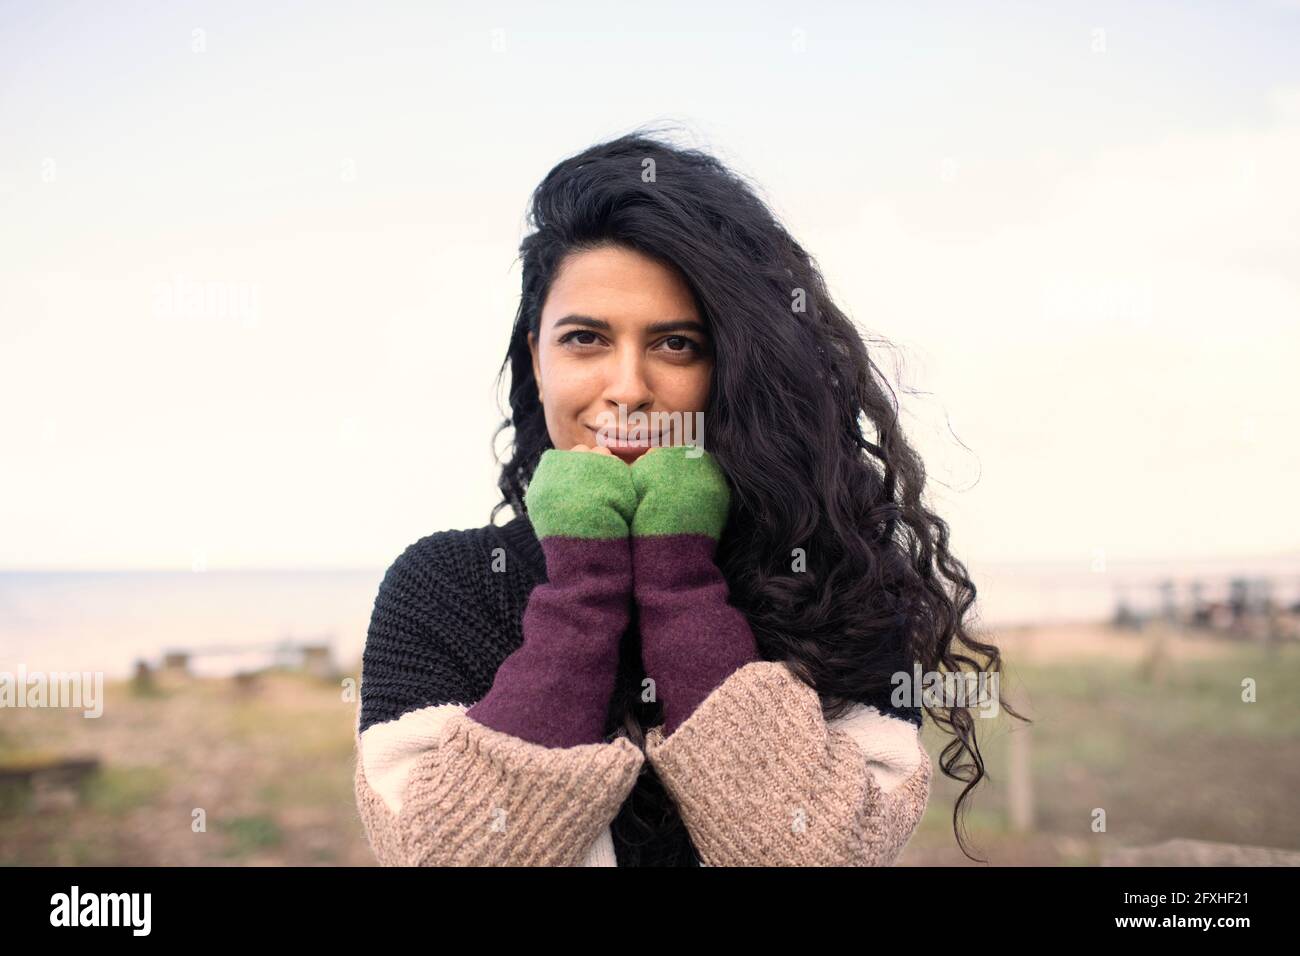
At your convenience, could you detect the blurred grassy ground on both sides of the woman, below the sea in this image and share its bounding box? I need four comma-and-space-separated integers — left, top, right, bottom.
0, 628, 1300, 865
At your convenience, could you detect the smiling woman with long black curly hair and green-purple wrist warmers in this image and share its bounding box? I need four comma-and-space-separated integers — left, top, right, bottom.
356, 127, 1014, 866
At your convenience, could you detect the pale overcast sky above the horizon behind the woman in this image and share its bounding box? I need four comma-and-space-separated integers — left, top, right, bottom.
0, 3, 1300, 568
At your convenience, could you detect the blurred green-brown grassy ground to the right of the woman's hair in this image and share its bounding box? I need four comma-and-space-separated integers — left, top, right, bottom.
900, 628, 1300, 865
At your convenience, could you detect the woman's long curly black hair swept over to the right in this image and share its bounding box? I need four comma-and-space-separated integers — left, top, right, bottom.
491, 121, 1026, 865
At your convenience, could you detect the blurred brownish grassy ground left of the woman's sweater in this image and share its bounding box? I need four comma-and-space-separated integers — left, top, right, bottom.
0, 672, 373, 866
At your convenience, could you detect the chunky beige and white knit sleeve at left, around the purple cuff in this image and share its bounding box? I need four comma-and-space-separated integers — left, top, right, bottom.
355, 704, 645, 866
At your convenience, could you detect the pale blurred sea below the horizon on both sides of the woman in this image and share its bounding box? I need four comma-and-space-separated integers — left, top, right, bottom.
0, 554, 1300, 679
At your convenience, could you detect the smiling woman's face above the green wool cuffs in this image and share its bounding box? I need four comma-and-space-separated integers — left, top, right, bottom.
528, 246, 714, 462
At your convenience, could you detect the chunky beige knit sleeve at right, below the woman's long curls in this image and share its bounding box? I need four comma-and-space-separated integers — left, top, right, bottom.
645, 661, 931, 866
